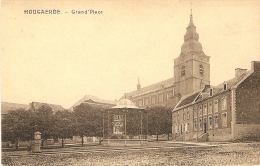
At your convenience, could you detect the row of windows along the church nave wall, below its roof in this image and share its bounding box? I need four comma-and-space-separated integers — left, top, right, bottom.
133, 90, 174, 107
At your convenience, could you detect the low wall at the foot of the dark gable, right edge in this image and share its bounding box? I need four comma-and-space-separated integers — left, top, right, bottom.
234, 124, 260, 141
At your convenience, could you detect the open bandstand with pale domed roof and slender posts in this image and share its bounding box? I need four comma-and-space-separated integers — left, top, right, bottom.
103, 99, 148, 146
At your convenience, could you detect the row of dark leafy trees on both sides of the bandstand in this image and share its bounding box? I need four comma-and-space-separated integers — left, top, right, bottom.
2, 103, 172, 142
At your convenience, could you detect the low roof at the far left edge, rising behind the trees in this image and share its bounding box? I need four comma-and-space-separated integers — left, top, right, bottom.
1, 102, 29, 118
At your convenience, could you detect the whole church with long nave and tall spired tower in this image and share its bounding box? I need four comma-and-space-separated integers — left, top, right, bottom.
122, 14, 210, 109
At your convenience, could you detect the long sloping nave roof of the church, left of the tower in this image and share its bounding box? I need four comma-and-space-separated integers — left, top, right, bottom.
120, 77, 174, 99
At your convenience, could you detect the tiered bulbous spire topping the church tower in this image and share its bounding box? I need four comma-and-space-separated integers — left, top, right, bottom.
181, 10, 202, 53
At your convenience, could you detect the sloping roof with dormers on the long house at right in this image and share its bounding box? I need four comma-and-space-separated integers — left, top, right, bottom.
173, 71, 252, 111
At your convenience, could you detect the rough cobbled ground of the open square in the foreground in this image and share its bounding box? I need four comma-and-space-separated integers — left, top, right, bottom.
2, 143, 260, 165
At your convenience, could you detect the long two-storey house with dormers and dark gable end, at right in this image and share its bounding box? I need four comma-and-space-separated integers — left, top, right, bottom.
172, 61, 260, 141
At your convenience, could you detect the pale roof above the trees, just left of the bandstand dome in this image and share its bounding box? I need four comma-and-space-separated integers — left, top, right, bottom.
69, 95, 117, 111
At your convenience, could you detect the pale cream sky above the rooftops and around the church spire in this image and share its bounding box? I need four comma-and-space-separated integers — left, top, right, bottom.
1, 0, 260, 108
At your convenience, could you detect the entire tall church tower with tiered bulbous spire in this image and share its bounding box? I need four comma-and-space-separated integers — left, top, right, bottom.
174, 13, 210, 96
